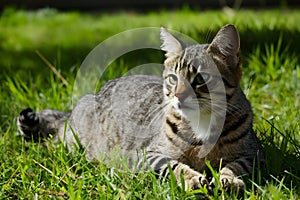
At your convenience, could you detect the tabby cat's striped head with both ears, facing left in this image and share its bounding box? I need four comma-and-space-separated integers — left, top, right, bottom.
160, 25, 241, 114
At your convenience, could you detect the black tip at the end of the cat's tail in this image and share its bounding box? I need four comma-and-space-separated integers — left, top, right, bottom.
17, 108, 39, 139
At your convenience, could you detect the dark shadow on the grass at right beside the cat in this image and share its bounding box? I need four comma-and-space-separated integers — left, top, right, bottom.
256, 120, 300, 191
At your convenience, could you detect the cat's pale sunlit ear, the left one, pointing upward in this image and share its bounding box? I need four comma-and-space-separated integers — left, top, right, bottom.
160, 27, 184, 58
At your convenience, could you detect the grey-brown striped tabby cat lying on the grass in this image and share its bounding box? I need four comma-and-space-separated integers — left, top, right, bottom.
17, 24, 264, 190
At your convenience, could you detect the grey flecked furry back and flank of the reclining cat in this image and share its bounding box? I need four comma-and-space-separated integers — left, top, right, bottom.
67, 75, 163, 158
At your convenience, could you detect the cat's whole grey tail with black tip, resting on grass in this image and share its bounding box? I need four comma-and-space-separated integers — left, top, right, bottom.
17, 108, 71, 142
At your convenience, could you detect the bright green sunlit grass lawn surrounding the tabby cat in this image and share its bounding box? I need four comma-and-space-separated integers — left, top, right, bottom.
0, 9, 300, 199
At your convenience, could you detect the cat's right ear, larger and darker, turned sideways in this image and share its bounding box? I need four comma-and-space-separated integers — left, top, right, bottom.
207, 24, 240, 65
